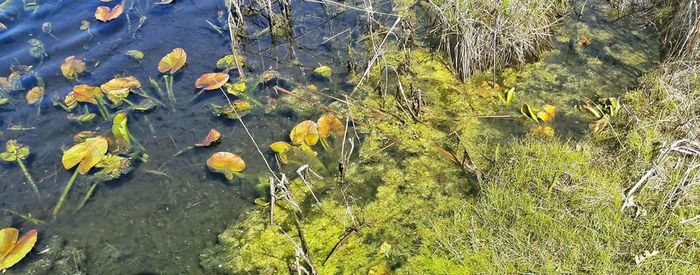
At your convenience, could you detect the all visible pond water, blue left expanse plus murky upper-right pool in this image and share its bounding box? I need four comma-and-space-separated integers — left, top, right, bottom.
0, 0, 658, 274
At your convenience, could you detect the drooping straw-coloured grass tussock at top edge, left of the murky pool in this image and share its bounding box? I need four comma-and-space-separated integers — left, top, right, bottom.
429, 0, 567, 80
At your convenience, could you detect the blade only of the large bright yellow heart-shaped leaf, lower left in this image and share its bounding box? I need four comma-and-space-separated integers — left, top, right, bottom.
61, 136, 109, 175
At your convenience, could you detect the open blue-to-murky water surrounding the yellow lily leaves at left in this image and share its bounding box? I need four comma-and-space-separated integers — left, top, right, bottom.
0, 0, 370, 274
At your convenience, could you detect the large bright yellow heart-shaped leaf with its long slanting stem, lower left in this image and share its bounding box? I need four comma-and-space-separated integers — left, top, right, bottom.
53, 136, 109, 218
